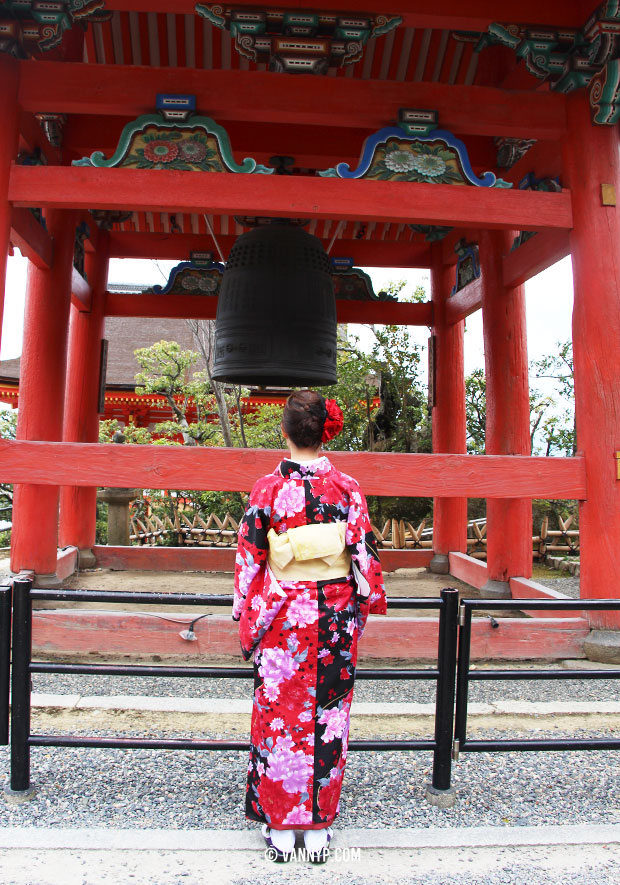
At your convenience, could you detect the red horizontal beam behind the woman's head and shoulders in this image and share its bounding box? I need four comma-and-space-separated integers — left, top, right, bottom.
0, 440, 586, 499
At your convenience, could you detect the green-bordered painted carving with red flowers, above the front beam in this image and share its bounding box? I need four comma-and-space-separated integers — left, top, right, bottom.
73, 114, 274, 175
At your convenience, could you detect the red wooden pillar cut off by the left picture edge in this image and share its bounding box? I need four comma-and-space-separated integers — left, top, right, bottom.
0, 52, 19, 348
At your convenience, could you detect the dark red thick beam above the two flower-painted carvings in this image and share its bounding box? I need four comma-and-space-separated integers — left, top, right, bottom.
19, 60, 572, 139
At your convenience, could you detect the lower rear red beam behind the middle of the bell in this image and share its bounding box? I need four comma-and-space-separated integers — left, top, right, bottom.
105, 292, 433, 326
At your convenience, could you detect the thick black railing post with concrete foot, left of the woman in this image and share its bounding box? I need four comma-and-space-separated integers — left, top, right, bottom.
4, 578, 35, 802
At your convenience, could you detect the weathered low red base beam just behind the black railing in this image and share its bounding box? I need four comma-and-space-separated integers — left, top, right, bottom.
33, 607, 589, 661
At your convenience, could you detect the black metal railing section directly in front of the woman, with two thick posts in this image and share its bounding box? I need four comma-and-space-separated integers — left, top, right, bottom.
4, 579, 458, 792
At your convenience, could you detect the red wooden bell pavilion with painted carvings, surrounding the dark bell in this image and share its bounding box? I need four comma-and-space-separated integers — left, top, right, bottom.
0, 0, 620, 660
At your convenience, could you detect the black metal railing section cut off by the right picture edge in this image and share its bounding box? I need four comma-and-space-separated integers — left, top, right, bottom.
453, 599, 620, 760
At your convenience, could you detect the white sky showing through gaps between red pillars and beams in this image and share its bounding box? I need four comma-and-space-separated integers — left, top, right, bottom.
0, 253, 573, 393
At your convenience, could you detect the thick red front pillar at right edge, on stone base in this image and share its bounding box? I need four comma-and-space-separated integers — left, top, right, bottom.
563, 93, 620, 662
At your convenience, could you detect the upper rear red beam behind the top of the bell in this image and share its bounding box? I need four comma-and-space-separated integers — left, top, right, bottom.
108, 231, 430, 267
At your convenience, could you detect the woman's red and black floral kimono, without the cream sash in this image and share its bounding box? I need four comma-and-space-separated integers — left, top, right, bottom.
233, 457, 386, 830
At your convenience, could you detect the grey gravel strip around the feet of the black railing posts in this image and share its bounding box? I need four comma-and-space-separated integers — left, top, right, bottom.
0, 729, 620, 829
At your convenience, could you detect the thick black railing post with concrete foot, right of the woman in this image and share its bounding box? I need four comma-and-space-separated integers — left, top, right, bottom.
426, 588, 459, 808
